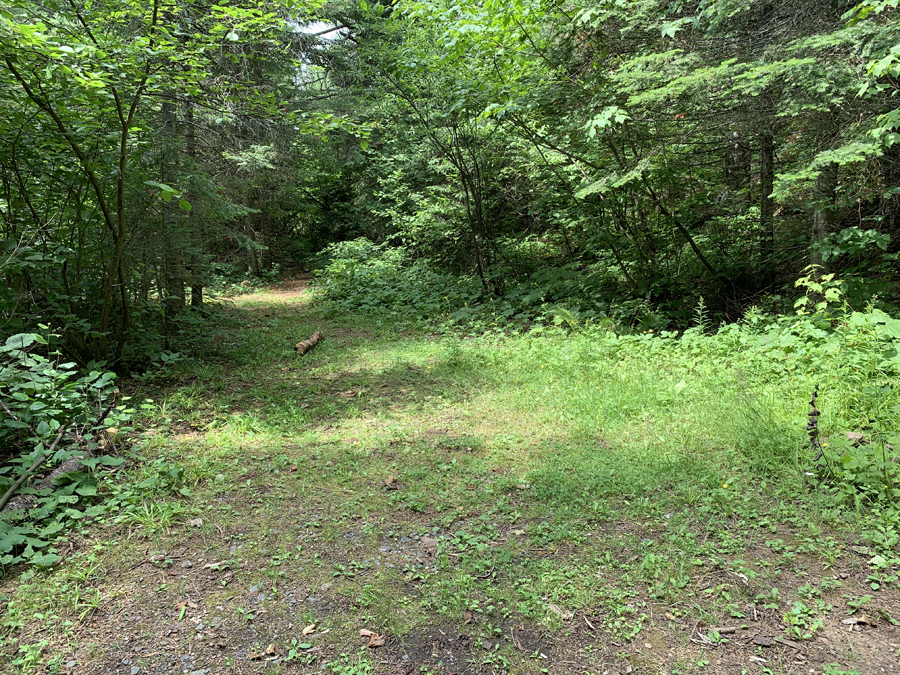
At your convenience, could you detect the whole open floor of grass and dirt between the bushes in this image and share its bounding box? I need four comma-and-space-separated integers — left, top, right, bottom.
2, 281, 900, 675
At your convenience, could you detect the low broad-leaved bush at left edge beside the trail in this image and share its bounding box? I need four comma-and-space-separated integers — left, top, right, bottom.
0, 333, 131, 566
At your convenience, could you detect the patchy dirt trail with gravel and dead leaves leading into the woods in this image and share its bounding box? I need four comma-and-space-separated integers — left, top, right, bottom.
2, 277, 900, 675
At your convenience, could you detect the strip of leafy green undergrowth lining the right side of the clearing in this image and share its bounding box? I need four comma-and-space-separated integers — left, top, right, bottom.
317, 248, 900, 550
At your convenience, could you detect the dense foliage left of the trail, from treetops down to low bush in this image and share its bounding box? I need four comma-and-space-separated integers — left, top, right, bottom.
0, 0, 356, 565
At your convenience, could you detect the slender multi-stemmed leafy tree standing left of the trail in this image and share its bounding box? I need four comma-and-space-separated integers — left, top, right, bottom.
0, 0, 326, 362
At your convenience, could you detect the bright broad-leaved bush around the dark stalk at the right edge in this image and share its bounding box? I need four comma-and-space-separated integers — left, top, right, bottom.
640, 306, 900, 505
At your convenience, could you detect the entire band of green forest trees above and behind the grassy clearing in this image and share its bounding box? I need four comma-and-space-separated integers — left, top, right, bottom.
0, 0, 900, 360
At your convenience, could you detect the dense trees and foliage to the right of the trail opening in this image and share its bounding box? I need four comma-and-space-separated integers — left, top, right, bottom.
310, 0, 900, 326
